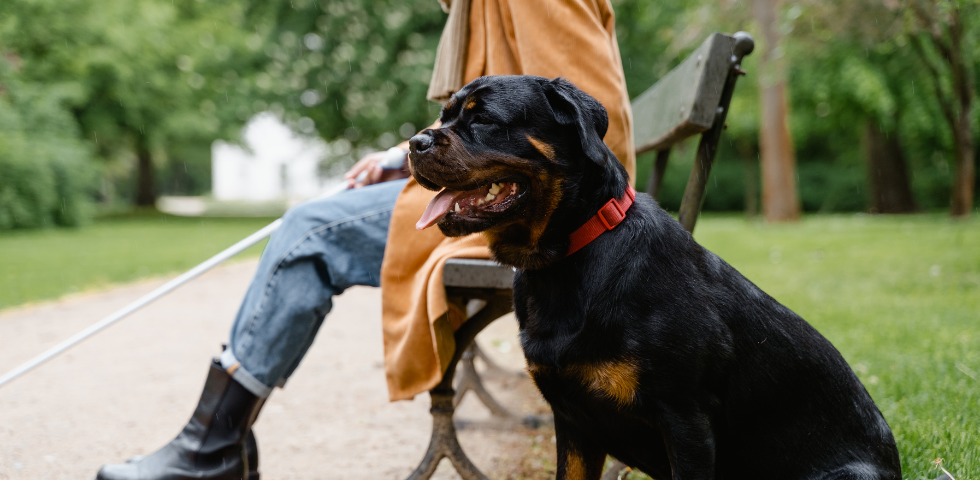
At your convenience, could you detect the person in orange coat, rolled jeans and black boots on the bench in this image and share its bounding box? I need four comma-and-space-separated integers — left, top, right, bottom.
97, 0, 635, 480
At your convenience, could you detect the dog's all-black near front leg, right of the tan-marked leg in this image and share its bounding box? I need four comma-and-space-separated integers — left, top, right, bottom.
660, 407, 715, 480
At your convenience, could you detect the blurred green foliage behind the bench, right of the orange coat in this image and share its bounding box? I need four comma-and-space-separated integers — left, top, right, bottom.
613, 0, 980, 212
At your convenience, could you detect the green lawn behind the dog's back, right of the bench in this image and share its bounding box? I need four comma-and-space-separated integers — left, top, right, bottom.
630, 215, 980, 480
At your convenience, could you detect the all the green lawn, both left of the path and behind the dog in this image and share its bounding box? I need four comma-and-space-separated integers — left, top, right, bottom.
0, 215, 980, 480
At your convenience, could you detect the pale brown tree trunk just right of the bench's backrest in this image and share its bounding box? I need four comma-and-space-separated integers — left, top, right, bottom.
752, 0, 800, 222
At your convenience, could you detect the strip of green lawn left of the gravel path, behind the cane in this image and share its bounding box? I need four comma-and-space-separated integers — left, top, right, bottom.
0, 214, 272, 309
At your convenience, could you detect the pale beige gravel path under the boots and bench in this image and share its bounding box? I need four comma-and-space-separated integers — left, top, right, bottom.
0, 260, 554, 480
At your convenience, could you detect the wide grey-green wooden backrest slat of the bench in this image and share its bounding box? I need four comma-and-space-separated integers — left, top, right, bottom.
632, 32, 735, 154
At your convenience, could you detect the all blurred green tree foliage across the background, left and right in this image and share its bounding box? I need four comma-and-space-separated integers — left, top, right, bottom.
0, 0, 980, 222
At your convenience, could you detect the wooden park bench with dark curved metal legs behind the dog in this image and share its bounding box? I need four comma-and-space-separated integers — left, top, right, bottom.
409, 32, 754, 480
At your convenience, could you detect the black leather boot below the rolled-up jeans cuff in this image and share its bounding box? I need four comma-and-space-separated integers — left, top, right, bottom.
96, 360, 264, 480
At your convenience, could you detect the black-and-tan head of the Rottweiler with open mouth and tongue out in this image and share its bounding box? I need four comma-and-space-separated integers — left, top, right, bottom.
409, 76, 628, 269
